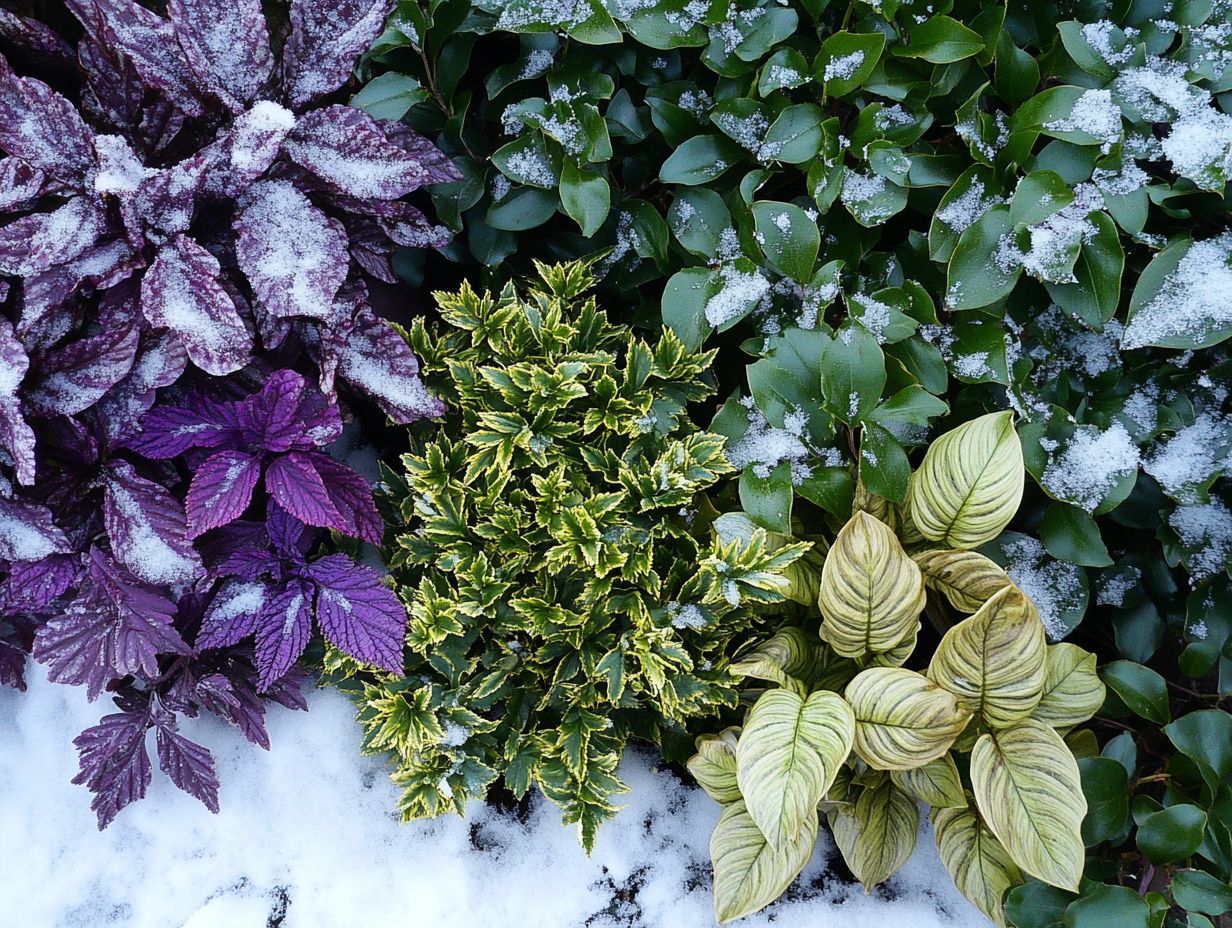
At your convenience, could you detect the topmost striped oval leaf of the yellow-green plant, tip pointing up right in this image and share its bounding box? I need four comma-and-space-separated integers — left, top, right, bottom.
908, 412, 1023, 548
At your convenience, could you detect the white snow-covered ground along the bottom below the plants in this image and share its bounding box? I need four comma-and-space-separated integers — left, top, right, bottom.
0, 668, 988, 928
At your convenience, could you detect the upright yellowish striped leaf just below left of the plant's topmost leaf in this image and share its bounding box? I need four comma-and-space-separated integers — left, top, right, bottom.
818, 511, 925, 657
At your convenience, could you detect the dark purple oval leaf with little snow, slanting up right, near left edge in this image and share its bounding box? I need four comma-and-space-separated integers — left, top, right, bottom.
26, 327, 140, 415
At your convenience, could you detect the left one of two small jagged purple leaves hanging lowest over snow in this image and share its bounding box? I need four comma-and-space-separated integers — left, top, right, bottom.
73, 712, 150, 831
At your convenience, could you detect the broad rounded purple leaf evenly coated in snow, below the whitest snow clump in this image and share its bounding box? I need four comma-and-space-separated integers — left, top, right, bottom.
235, 180, 350, 320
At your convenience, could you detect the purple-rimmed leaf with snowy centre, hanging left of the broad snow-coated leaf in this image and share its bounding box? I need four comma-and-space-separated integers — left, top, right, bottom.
142, 235, 253, 377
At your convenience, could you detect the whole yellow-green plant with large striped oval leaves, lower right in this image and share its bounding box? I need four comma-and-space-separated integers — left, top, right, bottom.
689, 413, 1104, 926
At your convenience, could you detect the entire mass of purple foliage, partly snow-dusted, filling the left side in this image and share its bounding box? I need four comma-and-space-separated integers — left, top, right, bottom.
0, 0, 457, 827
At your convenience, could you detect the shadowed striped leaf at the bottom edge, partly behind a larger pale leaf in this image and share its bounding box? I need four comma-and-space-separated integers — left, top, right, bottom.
931, 806, 1023, 928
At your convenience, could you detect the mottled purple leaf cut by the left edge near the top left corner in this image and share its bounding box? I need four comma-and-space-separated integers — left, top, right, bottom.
0, 65, 94, 182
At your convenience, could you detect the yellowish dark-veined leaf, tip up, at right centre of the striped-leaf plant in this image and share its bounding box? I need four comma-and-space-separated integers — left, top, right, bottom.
928, 585, 1047, 728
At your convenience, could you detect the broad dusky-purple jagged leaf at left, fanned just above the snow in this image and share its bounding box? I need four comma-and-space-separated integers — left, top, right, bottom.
34, 548, 188, 700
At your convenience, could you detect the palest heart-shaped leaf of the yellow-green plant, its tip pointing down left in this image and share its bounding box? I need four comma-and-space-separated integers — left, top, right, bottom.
736, 689, 855, 848
